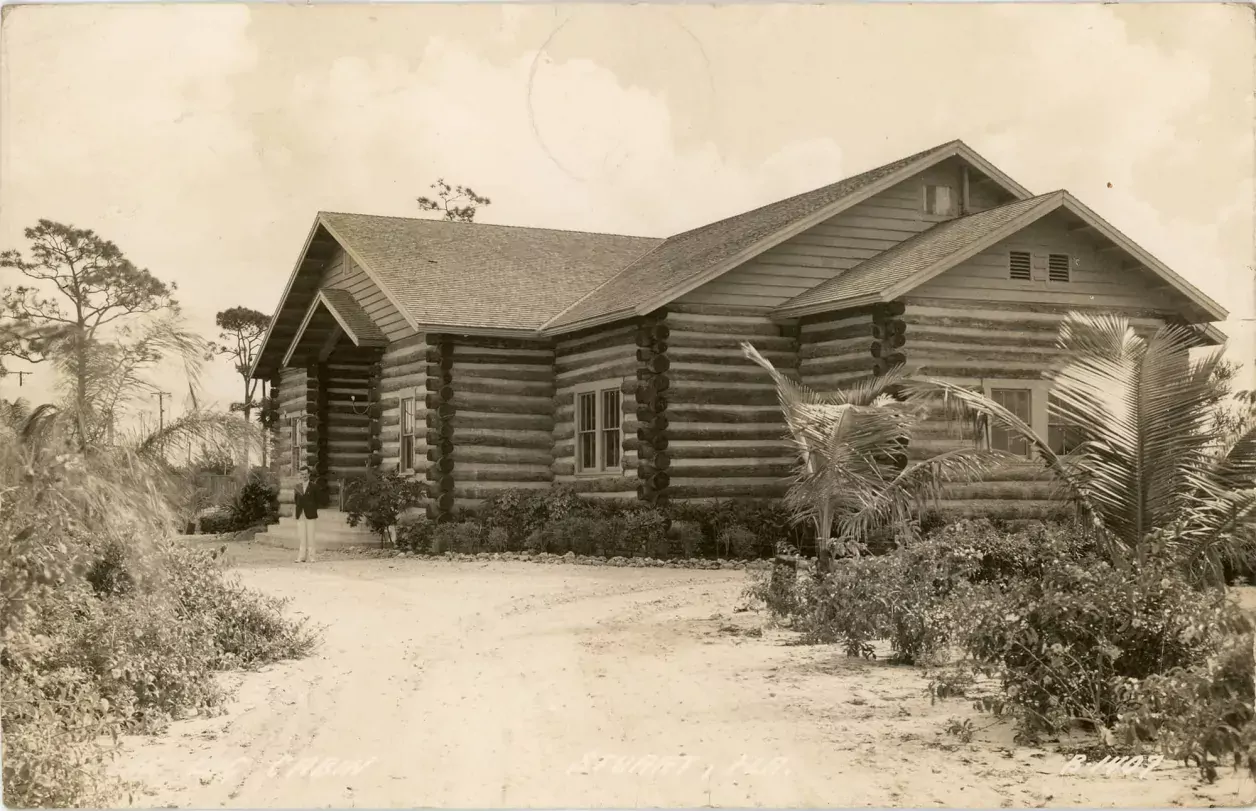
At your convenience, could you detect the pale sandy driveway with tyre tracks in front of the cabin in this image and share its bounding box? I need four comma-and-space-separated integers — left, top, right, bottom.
117, 542, 1256, 807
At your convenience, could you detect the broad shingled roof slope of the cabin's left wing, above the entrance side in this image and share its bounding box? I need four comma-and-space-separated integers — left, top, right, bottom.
319, 212, 661, 330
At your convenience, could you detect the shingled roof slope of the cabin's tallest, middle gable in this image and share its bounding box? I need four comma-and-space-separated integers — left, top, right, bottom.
546, 142, 957, 328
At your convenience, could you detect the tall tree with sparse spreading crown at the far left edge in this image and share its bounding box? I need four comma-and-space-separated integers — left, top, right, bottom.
0, 220, 178, 447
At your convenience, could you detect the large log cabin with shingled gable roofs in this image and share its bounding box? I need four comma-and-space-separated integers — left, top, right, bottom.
251, 141, 1226, 518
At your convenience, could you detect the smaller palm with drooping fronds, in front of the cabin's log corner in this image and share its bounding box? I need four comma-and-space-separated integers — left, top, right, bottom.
741, 343, 1002, 559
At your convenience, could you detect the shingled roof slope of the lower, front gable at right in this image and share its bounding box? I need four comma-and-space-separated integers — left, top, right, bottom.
776, 192, 1063, 314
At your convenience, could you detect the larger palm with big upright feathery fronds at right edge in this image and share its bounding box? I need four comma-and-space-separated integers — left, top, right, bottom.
904, 313, 1256, 583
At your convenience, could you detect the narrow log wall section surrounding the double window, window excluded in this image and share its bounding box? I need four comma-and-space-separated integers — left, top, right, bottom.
550, 323, 641, 500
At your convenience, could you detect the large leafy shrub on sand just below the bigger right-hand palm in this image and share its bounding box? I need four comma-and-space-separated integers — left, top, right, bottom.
958, 559, 1237, 739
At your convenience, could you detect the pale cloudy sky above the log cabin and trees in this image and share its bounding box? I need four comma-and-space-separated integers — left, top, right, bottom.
0, 4, 1256, 426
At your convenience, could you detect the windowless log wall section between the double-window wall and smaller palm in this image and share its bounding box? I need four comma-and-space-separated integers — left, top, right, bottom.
664, 305, 798, 501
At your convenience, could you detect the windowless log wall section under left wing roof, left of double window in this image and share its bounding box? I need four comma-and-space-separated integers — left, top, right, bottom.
444, 335, 554, 510
